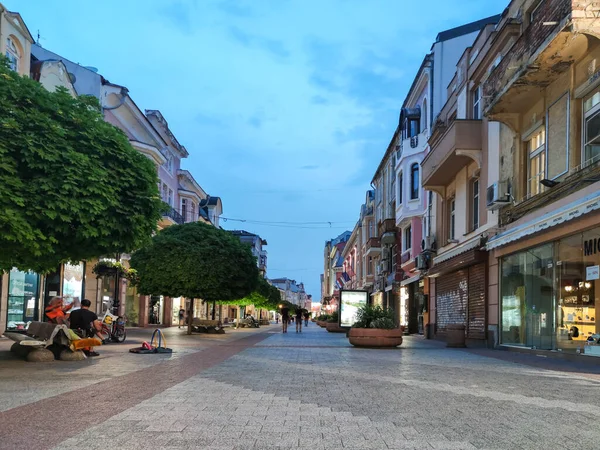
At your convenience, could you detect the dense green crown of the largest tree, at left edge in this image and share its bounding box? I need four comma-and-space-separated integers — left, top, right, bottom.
0, 59, 163, 272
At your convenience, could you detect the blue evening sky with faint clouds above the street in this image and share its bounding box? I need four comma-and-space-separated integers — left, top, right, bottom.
10, 0, 508, 299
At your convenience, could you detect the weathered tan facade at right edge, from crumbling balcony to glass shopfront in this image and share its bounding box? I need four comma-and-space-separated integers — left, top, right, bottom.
483, 0, 600, 354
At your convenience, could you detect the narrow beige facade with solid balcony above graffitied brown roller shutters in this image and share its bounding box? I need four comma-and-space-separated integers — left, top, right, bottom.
422, 23, 504, 345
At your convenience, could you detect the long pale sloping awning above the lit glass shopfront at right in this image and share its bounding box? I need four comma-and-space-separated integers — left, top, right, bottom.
486, 192, 600, 250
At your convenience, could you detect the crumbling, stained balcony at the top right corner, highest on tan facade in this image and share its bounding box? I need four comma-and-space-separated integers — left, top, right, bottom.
483, 0, 588, 118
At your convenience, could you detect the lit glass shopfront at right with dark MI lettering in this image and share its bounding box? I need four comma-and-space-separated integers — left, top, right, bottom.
500, 227, 600, 354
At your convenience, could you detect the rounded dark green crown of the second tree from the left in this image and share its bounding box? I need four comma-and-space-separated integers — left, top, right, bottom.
130, 222, 258, 302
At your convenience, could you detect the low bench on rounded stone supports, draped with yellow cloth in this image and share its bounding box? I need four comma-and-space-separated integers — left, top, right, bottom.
4, 322, 102, 361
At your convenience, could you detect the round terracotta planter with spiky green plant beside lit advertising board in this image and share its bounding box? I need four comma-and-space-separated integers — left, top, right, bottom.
348, 305, 404, 348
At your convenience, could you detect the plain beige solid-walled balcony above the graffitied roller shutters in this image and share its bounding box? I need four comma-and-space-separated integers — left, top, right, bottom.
421, 120, 482, 190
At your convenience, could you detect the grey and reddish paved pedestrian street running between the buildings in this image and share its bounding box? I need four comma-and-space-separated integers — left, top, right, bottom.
0, 323, 600, 450
